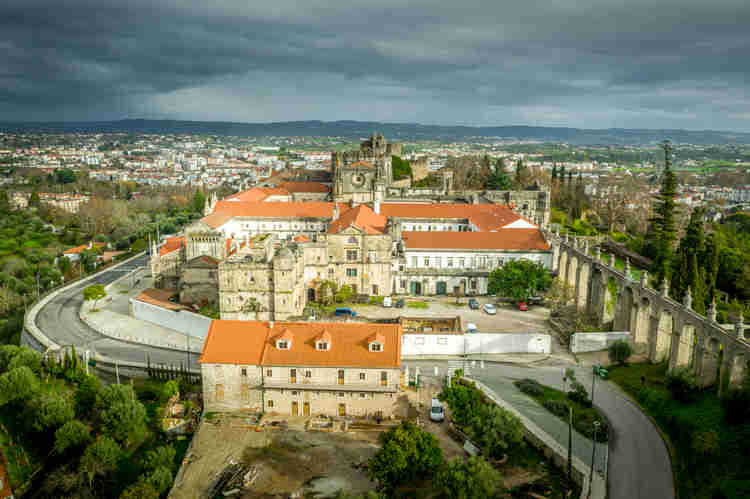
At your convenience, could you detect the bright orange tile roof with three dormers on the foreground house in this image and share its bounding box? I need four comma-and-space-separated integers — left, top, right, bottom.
200, 320, 402, 368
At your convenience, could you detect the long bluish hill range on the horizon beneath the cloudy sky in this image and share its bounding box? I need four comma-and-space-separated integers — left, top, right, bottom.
0, 119, 750, 145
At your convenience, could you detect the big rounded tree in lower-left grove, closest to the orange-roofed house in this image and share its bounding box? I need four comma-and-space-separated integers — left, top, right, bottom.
94, 385, 146, 443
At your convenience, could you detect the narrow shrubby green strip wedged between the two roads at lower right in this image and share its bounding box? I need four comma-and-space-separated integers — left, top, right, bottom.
513, 379, 609, 442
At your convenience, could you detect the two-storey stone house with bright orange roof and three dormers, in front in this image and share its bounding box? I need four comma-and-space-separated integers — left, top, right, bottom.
200, 320, 405, 418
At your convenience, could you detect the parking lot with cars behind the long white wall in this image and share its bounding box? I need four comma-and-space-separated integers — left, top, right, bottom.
352, 296, 549, 333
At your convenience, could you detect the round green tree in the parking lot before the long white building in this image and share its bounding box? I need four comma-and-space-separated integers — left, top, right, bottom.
487, 259, 552, 300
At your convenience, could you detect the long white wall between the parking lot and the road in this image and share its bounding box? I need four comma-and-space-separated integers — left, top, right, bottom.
401, 333, 551, 357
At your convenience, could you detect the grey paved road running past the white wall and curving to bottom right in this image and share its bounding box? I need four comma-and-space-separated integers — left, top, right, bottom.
406, 361, 675, 499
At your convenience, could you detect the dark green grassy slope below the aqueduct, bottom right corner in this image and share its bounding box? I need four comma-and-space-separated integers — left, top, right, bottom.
609, 363, 750, 499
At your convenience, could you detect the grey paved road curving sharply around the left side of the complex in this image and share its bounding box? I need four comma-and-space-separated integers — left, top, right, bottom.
36, 255, 199, 369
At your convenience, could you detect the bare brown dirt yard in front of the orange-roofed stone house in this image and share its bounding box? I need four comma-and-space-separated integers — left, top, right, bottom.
169, 414, 380, 499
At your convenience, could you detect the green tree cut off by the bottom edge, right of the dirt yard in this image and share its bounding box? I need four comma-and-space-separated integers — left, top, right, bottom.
433, 456, 503, 499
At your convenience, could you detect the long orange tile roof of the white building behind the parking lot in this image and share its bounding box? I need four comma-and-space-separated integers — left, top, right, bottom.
401, 229, 550, 251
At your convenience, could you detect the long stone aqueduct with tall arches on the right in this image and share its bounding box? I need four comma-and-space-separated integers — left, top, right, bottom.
547, 234, 750, 390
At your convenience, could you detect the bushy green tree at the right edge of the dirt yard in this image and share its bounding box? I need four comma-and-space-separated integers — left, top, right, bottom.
368, 421, 444, 490
